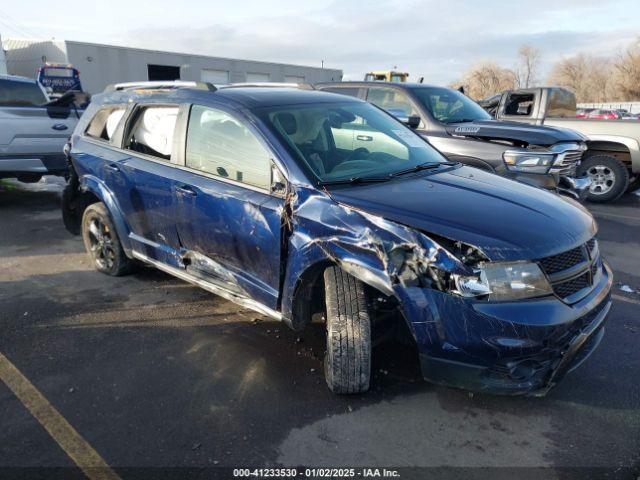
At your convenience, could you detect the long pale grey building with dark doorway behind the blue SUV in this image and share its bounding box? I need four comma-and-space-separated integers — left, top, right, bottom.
4, 38, 342, 93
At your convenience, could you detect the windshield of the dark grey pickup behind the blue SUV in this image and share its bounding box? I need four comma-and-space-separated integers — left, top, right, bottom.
413, 87, 492, 123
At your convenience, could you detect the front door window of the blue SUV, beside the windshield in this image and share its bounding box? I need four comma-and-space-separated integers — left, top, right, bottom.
185, 105, 271, 189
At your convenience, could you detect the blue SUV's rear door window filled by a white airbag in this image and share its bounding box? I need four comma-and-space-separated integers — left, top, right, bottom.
124, 106, 178, 160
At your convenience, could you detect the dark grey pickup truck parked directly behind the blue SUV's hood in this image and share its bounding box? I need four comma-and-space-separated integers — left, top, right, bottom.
315, 82, 589, 198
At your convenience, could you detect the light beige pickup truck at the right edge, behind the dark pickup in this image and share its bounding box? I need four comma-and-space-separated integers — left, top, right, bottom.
479, 87, 640, 202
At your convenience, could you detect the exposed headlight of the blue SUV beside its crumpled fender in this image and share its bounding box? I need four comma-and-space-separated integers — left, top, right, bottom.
453, 262, 553, 301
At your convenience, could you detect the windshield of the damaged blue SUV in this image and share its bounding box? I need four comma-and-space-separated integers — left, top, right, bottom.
256, 102, 447, 182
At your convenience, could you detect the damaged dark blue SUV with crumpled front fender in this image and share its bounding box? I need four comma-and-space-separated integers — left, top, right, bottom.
63, 83, 612, 394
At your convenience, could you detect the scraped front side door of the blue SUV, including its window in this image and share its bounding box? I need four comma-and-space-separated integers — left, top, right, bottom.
174, 105, 284, 309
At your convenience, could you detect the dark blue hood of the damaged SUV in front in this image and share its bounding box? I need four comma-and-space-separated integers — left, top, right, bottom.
330, 167, 597, 261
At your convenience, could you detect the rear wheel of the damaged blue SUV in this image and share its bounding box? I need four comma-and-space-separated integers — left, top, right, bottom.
82, 202, 133, 277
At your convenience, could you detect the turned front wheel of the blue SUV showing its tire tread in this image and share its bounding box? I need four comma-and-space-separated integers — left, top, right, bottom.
324, 267, 371, 393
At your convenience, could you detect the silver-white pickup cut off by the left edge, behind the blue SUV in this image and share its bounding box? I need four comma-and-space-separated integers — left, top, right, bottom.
0, 75, 81, 182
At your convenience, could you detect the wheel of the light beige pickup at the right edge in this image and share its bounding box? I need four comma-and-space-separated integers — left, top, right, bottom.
578, 155, 629, 203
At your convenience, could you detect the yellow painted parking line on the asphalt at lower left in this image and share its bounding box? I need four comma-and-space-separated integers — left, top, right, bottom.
0, 353, 120, 480
